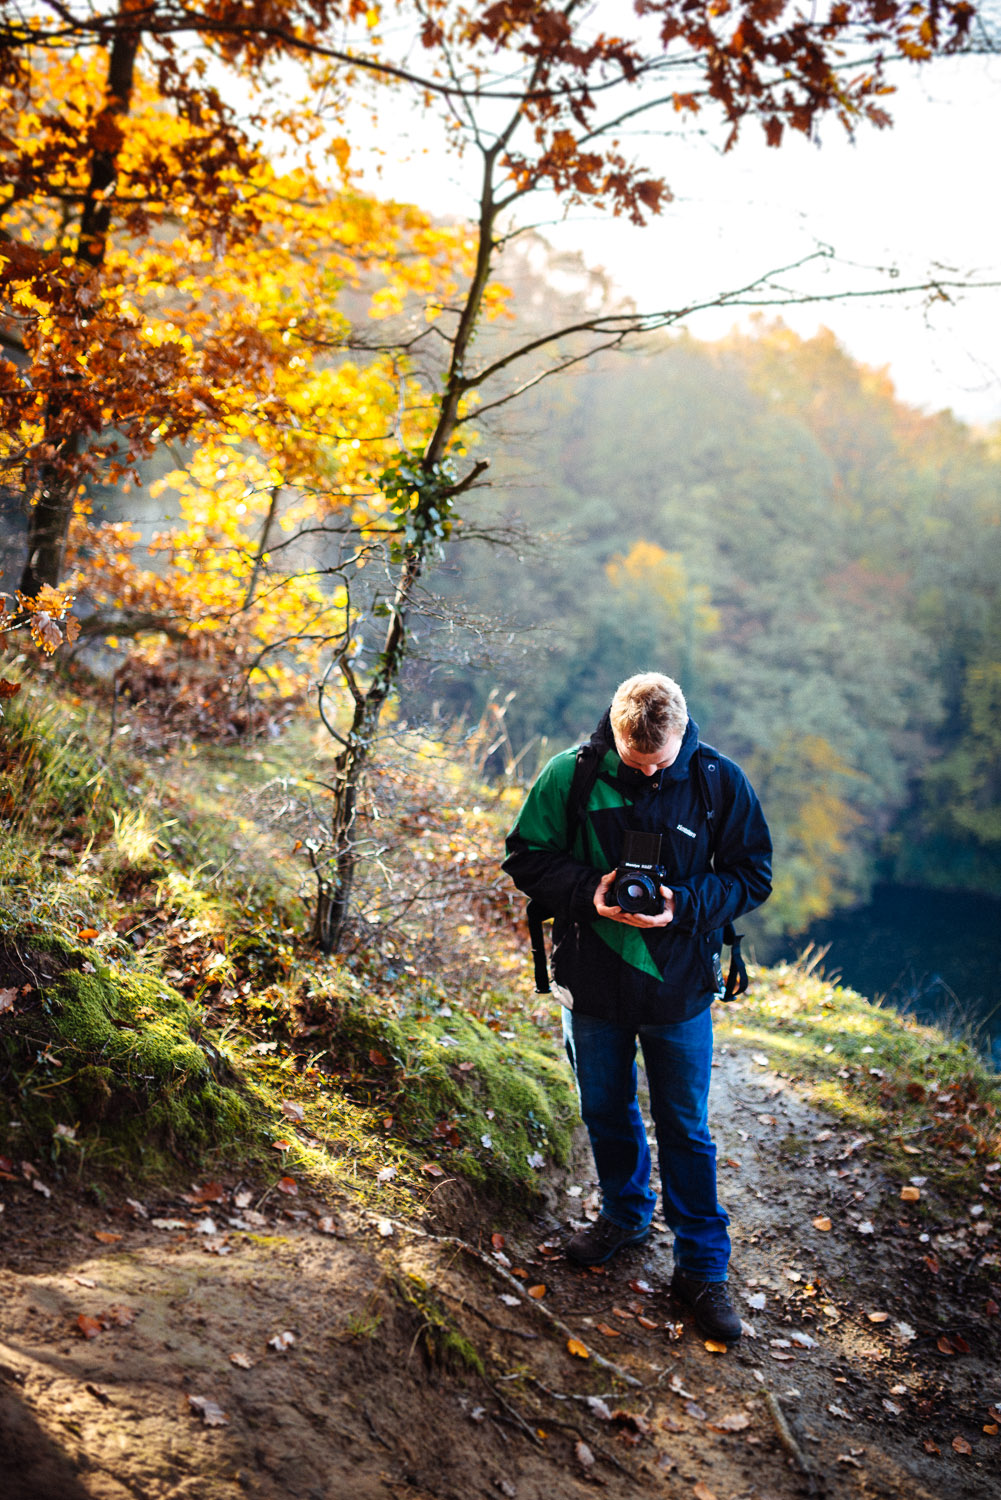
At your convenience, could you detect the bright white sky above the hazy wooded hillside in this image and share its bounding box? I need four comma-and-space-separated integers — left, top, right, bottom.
354, 57, 1001, 423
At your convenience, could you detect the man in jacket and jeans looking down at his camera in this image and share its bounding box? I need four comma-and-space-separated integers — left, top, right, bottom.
504, 672, 771, 1343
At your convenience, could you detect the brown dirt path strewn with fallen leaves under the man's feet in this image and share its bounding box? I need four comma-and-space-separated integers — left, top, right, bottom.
0, 1044, 1001, 1500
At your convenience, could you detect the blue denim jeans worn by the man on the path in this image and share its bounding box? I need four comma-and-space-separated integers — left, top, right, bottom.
563, 1007, 729, 1281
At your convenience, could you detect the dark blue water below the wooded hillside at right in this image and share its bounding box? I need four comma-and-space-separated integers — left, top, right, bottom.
783, 885, 1001, 1071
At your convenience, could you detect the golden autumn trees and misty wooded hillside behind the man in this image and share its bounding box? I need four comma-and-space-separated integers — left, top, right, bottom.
3, 6, 1001, 1020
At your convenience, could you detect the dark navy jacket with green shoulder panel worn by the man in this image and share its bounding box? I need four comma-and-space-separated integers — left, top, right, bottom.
504, 714, 771, 1026
